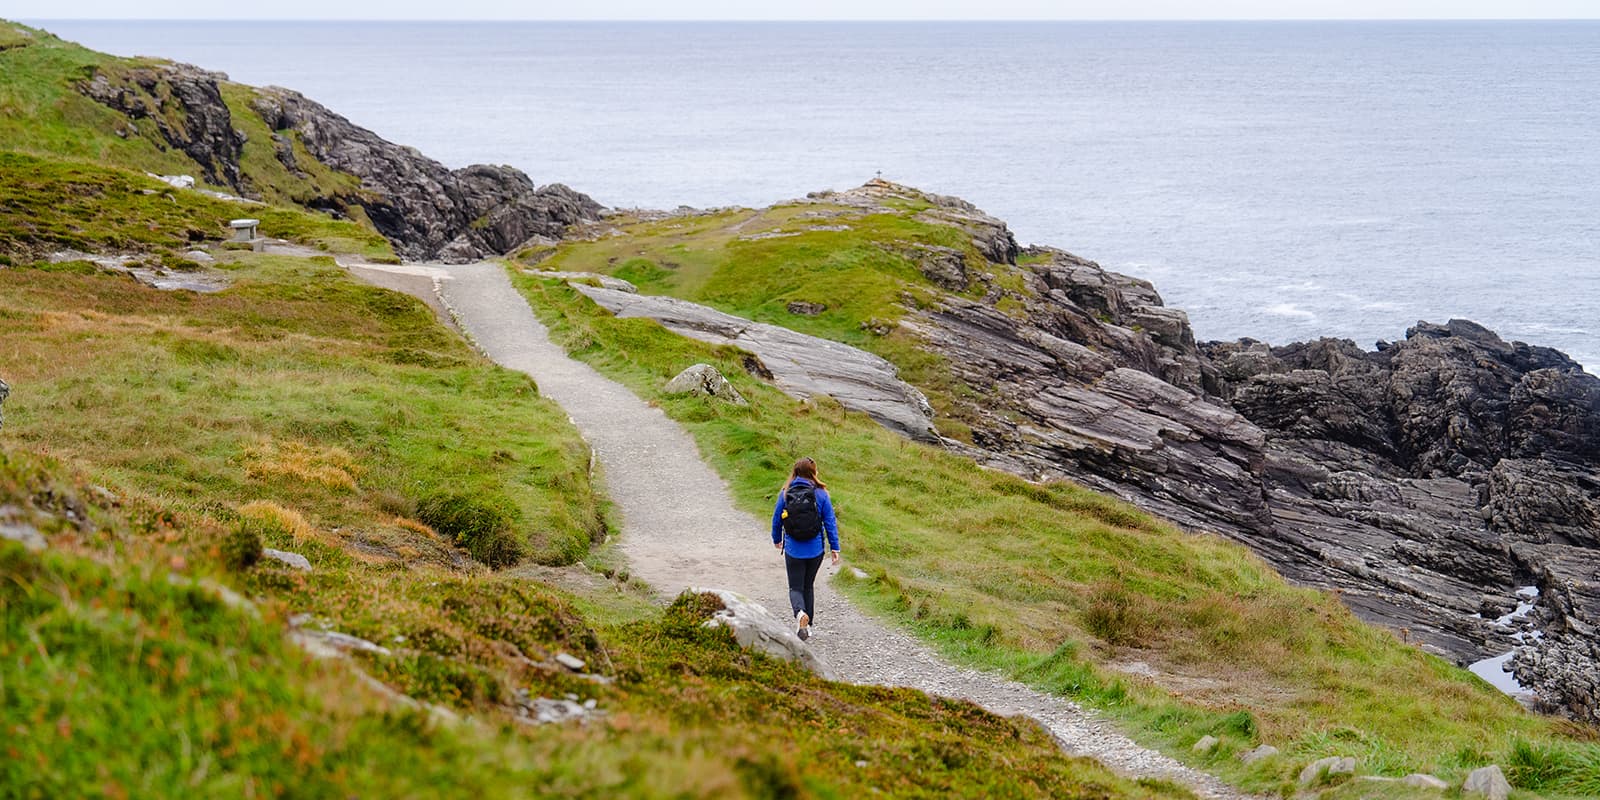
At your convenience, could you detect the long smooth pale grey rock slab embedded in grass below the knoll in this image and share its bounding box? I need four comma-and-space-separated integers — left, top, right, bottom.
574, 285, 939, 442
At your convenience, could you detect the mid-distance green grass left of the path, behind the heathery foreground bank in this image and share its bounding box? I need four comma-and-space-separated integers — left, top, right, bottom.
0, 254, 605, 563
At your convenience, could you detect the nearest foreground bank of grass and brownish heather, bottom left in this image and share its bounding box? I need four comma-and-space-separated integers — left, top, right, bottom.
0, 445, 1187, 798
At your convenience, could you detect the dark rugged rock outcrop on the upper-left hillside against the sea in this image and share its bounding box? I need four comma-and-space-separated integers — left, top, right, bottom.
78, 64, 600, 261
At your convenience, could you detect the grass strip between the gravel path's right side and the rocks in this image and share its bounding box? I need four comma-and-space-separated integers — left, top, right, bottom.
515, 272, 1600, 797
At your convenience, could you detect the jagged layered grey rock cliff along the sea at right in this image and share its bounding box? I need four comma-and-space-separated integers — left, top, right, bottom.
827, 184, 1600, 722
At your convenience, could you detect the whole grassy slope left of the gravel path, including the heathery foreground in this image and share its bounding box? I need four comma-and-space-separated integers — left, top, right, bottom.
0, 246, 1189, 800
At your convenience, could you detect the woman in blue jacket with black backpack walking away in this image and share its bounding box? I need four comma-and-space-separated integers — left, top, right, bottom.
773, 458, 838, 640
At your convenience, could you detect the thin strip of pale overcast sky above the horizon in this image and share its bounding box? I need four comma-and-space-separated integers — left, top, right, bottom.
12, 0, 1600, 19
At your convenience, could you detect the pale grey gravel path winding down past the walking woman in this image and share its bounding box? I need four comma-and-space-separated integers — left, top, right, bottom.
358, 264, 1250, 798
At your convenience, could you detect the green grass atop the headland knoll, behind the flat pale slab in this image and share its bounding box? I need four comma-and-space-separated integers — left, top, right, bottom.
523, 202, 1021, 440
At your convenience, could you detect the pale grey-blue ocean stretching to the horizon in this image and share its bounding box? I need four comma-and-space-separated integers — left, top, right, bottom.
35, 21, 1600, 371
